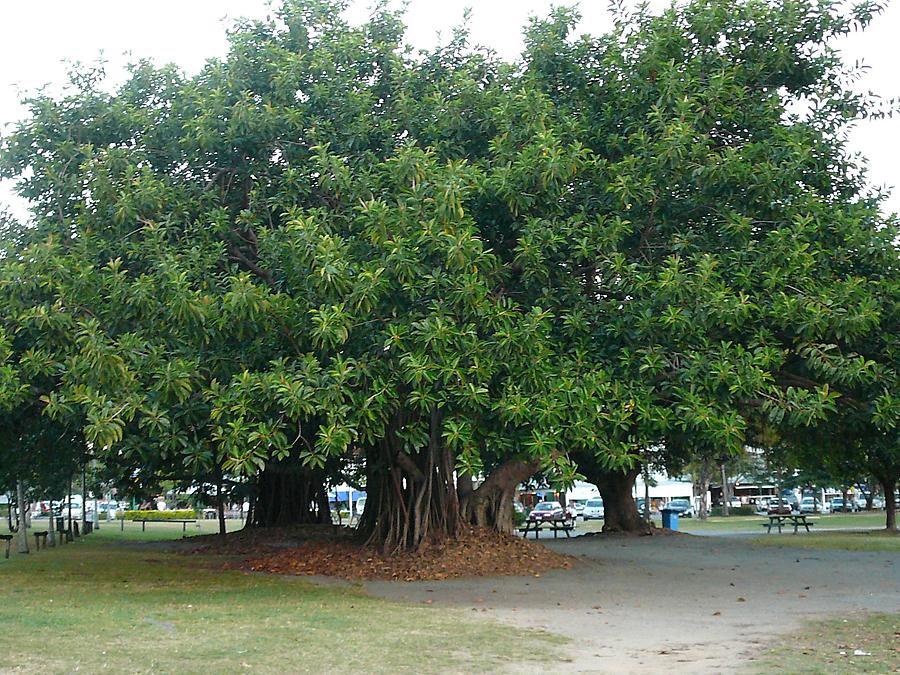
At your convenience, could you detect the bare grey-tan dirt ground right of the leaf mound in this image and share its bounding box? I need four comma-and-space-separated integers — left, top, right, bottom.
365, 535, 900, 673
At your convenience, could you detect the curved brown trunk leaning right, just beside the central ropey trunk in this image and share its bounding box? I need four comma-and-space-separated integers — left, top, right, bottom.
460, 459, 536, 532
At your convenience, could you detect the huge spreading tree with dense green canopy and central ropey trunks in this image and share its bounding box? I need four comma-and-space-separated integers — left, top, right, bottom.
0, 0, 900, 549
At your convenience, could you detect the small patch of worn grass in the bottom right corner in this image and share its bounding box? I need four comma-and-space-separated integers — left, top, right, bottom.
753, 614, 900, 675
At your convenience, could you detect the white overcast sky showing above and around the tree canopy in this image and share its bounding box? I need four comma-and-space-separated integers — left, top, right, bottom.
0, 0, 900, 215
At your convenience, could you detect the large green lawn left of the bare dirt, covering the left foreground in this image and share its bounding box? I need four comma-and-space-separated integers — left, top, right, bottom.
0, 522, 564, 673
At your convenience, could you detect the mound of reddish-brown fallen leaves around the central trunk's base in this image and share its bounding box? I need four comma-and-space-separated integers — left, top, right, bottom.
226, 528, 576, 581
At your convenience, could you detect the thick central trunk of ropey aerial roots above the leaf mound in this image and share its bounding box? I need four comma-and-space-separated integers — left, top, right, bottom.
359, 408, 460, 554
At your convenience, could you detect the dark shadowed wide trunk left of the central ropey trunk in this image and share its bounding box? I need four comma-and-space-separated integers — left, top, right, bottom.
247, 461, 330, 527
